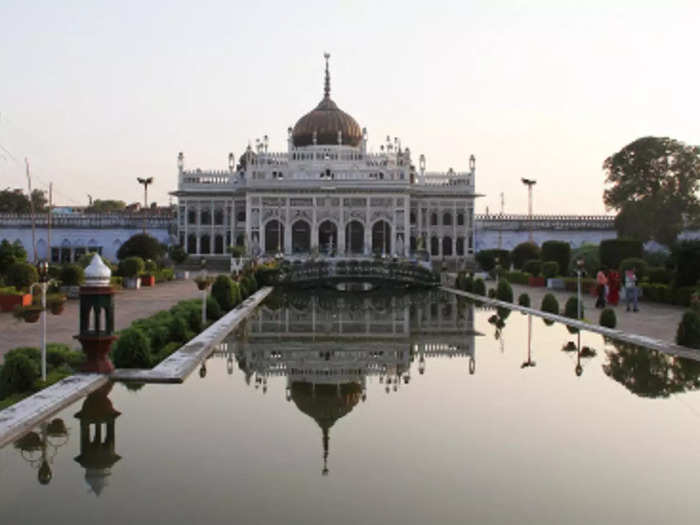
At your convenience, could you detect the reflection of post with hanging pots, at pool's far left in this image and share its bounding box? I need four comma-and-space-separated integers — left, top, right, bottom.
14, 418, 68, 485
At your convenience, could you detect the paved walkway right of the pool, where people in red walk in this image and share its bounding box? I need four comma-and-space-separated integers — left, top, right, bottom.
506, 281, 685, 344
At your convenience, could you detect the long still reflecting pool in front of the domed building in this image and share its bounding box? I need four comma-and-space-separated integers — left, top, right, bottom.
0, 291, 700, 524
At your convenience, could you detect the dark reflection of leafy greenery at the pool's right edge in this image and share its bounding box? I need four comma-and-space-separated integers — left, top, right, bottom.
603, 341, 700, 397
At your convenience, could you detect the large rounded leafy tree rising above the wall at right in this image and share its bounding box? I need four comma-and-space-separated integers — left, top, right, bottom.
603, 137, 700, 245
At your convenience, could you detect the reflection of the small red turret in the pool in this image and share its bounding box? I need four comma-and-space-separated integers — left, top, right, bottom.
75, 383, 121, 496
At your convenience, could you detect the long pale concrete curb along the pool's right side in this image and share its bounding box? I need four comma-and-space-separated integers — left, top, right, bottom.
440, 286, 700, 361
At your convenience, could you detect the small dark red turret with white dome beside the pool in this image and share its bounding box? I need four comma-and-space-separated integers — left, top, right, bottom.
75, 254, 117, 374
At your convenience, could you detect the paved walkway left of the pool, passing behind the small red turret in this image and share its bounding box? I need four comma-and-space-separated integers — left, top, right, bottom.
0, 281, 201, 358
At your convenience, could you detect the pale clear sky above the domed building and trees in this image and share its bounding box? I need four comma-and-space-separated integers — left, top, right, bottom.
0, 0, 700, 213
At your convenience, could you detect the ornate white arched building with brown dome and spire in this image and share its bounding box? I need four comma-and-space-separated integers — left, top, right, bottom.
172, 54, 477, 263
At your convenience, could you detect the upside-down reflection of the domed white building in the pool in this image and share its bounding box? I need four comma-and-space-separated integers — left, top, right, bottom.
215, 291, 476, 475
